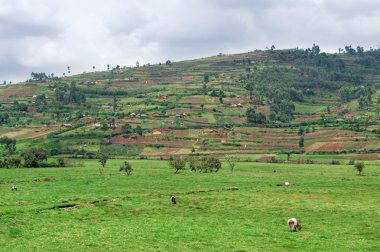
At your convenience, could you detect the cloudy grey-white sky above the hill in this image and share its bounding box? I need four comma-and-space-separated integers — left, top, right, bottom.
0, 0, 380, 83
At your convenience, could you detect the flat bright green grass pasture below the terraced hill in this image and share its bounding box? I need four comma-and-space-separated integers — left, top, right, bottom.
0, 160, 380, 251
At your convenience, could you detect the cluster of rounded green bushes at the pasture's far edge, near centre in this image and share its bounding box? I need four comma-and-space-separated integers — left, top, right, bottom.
168, 156, 222, 173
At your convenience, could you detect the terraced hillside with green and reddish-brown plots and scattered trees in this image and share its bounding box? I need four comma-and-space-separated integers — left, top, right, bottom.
0, 45, 380, 162
